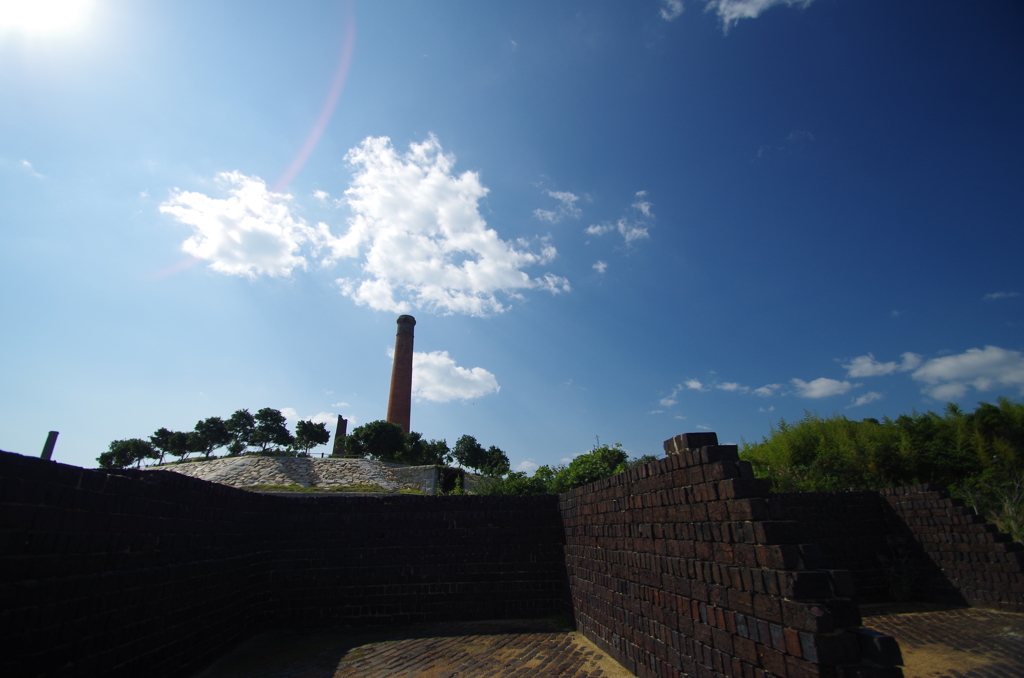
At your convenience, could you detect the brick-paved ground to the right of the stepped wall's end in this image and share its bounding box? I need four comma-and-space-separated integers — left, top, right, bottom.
863, 605, 1024, 678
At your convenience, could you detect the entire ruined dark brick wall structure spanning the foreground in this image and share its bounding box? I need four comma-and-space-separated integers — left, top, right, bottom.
0, 434, 1024, 678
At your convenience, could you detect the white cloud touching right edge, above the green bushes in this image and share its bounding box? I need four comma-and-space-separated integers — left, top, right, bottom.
911, 346, 1024, 400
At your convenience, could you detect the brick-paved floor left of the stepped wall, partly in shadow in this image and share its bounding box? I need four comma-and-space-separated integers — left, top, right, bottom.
195, 621, 633, 678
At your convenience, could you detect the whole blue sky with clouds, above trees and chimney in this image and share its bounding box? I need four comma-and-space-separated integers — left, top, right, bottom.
0, 0, 1024, 470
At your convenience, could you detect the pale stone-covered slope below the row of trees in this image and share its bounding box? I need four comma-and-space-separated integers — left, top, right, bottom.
144, 457, 418, 492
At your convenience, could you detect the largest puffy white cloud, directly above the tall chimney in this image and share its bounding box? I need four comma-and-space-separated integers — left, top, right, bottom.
327, 135, 570, 315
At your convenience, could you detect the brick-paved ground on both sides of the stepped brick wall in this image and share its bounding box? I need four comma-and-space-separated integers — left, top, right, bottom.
194, 605, 1024, 678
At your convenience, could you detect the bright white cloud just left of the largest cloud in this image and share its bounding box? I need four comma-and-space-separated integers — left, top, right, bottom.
160, 172, 311, 278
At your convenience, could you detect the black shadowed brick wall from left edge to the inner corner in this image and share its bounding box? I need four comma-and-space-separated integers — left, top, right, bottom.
0, 454, 567, 677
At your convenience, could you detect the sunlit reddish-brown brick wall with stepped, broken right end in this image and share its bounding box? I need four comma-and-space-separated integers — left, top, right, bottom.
561, 435, 901, 678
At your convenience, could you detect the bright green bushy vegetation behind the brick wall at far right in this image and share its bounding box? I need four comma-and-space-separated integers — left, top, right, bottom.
740, 398, 1024, 541
